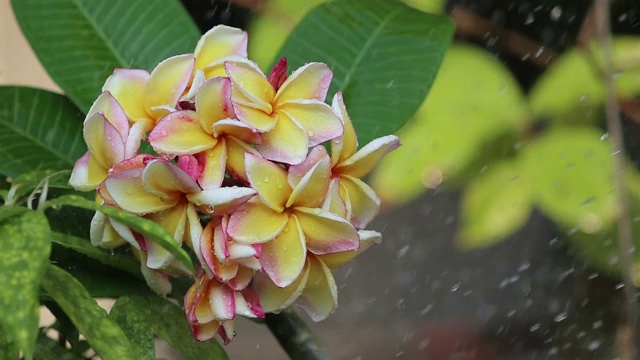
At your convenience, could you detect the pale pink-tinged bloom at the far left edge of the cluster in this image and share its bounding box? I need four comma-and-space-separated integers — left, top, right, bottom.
69, 91, 145, 191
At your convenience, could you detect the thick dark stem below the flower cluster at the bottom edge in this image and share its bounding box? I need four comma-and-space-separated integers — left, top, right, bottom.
265, 308, 331, 360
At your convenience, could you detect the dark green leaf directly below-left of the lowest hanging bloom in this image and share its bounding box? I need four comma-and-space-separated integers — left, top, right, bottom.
118, 296, 228, 360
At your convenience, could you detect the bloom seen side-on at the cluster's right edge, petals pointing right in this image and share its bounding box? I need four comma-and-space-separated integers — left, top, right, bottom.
324, 93, 400, 229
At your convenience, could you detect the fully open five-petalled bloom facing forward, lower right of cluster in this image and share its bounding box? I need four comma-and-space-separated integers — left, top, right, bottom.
227, 146, 359, 287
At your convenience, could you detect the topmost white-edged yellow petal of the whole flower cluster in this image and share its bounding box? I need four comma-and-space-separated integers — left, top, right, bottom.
194, 25, 248, 78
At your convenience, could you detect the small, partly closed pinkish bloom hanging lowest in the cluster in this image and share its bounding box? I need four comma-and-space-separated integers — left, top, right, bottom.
184, 271, 264, 344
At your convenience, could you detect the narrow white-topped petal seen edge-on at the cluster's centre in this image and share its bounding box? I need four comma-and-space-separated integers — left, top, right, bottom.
187, 186, 256, 216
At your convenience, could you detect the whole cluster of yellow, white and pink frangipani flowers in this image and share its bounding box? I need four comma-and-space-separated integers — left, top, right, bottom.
70, 26, 399, 343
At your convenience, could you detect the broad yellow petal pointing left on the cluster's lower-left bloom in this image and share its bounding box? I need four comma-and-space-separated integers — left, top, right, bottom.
104, 168, 180, 214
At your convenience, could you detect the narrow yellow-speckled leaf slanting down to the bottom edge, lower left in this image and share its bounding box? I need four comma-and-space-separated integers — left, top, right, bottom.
42, 264, 134, 360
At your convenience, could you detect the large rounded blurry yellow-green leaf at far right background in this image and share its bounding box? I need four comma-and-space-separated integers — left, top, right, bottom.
522, 127, 619, 233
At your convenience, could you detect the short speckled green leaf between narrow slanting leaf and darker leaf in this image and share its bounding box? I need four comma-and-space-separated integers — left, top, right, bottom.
109, 297, 155, 360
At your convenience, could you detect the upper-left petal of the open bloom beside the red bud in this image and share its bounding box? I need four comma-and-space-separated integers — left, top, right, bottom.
224, 61, 275, 114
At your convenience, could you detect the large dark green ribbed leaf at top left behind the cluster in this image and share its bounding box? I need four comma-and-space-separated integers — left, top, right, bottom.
11, 0, 200, 111
